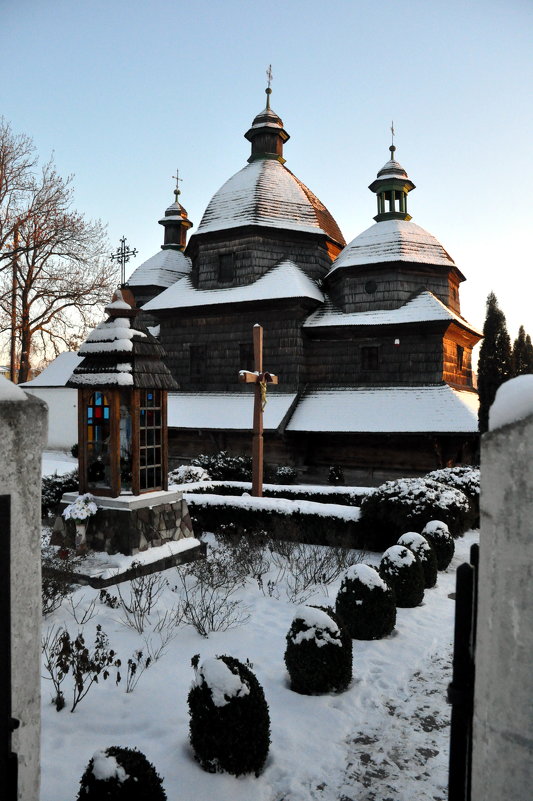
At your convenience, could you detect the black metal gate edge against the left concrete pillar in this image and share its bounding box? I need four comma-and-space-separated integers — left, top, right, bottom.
0, 495, 19, 801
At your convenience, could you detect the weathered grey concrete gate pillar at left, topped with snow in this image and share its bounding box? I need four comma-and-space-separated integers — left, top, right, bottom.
0, 388, 48, 801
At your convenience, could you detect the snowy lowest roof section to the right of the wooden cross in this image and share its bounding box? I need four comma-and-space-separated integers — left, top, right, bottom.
286, 384, 479, 434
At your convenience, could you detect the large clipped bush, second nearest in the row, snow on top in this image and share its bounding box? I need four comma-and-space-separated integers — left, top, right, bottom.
188, 656, 270, 776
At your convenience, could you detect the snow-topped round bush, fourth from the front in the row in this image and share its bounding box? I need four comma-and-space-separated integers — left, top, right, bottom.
335, 564, 396, 640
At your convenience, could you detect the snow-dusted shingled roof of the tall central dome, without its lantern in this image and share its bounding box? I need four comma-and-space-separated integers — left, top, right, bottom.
196, 156, 344, 245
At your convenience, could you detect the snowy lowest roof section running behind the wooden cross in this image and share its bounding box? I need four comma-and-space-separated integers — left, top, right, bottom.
168, 390, 296, 430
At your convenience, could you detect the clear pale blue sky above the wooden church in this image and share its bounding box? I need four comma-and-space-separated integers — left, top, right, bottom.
0, 0, 533, 350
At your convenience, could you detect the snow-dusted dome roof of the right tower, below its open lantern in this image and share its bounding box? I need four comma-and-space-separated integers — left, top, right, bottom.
328, 220, 455, 275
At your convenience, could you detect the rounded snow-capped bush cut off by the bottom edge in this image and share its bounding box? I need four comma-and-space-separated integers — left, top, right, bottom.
78, 745, 167, 801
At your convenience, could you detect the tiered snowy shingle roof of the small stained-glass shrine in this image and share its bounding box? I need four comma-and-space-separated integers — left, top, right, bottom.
65, 290, 179, 390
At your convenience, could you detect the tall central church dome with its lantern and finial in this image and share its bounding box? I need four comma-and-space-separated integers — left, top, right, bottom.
197, 83, 345, 246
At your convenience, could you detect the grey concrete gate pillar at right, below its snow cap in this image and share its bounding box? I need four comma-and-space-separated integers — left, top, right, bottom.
472, 416, 533, 801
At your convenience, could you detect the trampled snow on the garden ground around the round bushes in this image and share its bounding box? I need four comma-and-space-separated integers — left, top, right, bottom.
41, 532, 478, 801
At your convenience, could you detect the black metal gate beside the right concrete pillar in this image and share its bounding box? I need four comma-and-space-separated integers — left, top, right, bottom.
448, 545, 479, 801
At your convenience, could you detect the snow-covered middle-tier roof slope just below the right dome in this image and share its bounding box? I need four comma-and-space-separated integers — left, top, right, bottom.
304, 290, 481, 336
